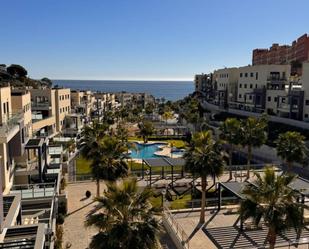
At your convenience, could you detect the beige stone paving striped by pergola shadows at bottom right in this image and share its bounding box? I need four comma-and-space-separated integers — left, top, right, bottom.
174, 210, 309, 249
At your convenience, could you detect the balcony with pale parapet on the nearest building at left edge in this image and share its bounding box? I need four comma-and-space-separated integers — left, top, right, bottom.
0, 111, 24, 143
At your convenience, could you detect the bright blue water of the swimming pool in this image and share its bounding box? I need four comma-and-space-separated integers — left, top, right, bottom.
130, 143, 166, 159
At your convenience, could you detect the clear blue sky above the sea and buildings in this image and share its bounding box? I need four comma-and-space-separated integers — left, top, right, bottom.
0, 0, 309, 80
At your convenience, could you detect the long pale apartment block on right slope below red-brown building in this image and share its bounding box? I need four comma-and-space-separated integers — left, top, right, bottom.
199, 62, 309, 124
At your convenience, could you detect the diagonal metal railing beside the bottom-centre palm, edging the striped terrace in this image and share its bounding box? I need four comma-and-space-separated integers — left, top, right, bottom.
163, 207, 190, 249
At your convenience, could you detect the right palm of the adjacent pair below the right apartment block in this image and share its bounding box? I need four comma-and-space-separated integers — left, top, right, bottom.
239, 116, 267, 178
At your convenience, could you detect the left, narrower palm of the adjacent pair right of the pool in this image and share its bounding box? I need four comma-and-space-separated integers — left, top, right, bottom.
220, 118, 240, 179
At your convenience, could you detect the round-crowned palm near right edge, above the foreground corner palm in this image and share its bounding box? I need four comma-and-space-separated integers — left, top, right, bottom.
276, 131, 308, 171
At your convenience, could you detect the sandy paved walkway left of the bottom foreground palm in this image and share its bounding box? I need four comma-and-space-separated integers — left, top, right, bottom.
63, 182, 104, 249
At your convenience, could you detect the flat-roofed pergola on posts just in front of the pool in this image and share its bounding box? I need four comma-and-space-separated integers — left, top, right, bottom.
142, 157, 185, 186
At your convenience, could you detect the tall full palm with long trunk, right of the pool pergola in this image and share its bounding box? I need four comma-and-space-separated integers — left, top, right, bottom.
184, 131, 224, 223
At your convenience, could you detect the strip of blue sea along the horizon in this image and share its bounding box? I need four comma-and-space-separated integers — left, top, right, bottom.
53, 80, 194, 101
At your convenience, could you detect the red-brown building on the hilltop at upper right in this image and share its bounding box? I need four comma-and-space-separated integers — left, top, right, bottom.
252, 34, 309, 65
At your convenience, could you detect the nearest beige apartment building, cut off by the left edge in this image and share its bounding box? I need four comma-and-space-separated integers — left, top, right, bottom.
0, 86, 31, 193
